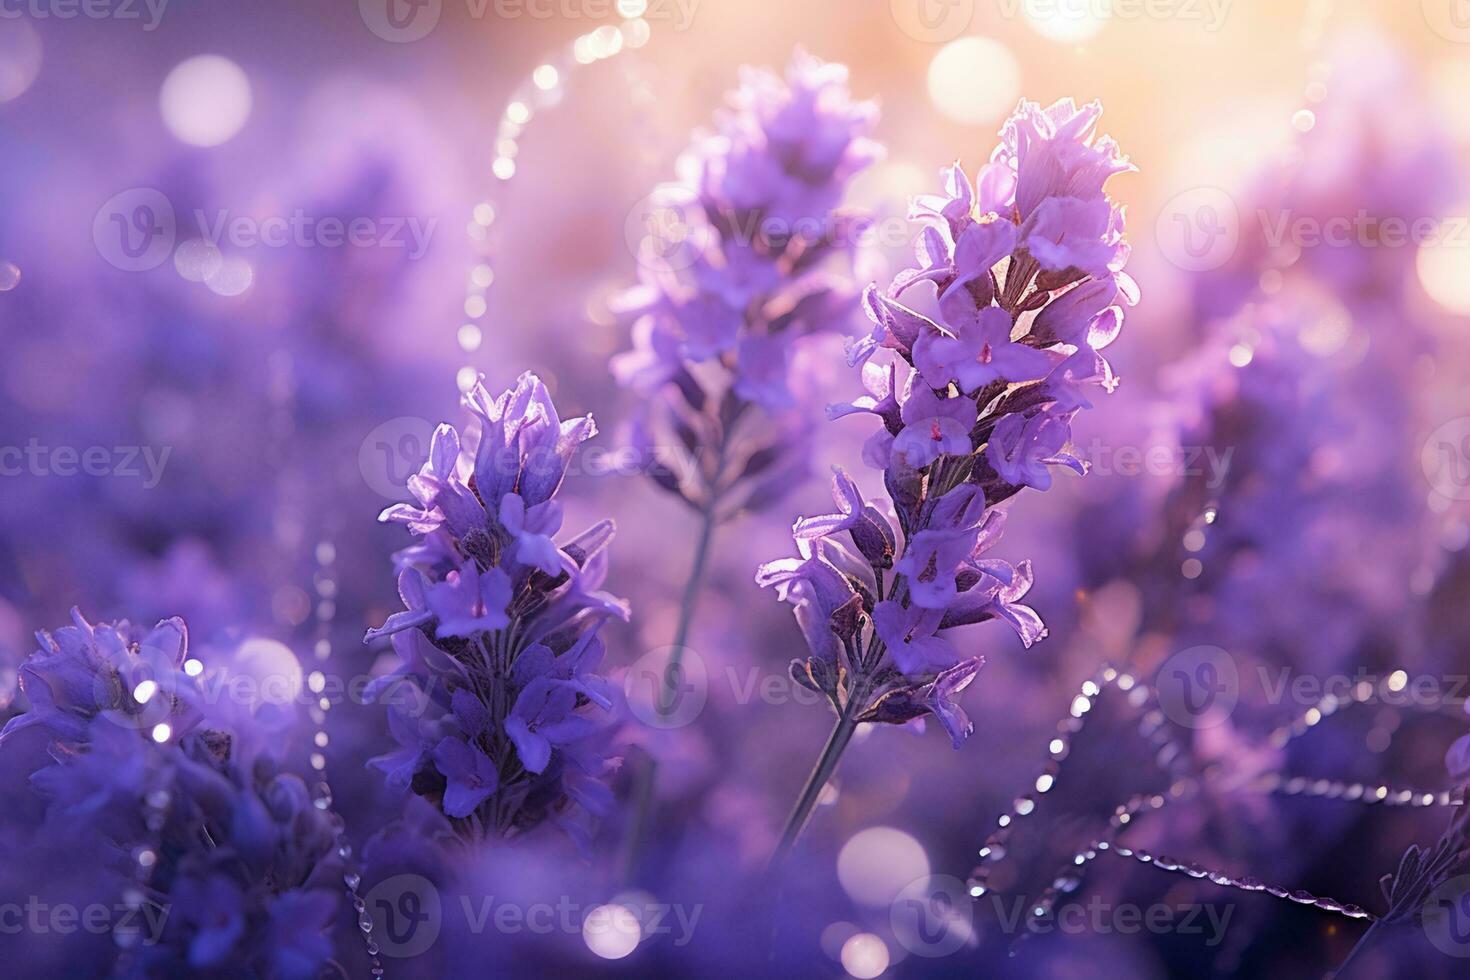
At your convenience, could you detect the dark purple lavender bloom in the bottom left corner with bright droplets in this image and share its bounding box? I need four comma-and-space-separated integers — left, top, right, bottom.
0, 611, 343, 979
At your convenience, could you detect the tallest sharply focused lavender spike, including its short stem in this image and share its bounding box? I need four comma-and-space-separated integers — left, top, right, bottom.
756, 100, 1138, 861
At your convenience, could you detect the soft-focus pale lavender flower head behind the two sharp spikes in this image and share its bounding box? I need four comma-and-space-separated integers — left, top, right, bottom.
612, 51, 879, 511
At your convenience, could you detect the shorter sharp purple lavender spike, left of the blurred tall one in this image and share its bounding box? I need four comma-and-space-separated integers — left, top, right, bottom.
368, 373, 628, 839
